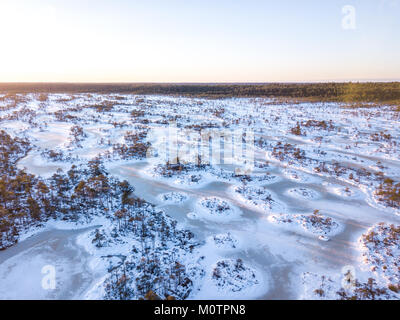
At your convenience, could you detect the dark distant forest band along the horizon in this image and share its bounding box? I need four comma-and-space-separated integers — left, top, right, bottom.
0, 82, 400, 105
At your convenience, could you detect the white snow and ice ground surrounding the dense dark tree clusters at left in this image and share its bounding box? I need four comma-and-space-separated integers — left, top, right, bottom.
0, 94, 400, 299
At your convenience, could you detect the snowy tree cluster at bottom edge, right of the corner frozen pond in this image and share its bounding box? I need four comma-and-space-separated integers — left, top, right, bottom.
101, 195, 198, 300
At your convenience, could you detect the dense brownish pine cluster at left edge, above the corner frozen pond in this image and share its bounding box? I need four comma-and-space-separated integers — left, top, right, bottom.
0, 131, 131, 249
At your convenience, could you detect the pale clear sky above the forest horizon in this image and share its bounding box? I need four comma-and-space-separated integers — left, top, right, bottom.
0, 0, 400, 82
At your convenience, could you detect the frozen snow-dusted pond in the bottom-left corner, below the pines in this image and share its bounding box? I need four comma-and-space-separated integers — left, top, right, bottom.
0, 228, 96, 299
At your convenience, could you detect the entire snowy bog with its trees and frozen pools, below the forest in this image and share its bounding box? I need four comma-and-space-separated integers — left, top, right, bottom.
0, 93, 400, 299
